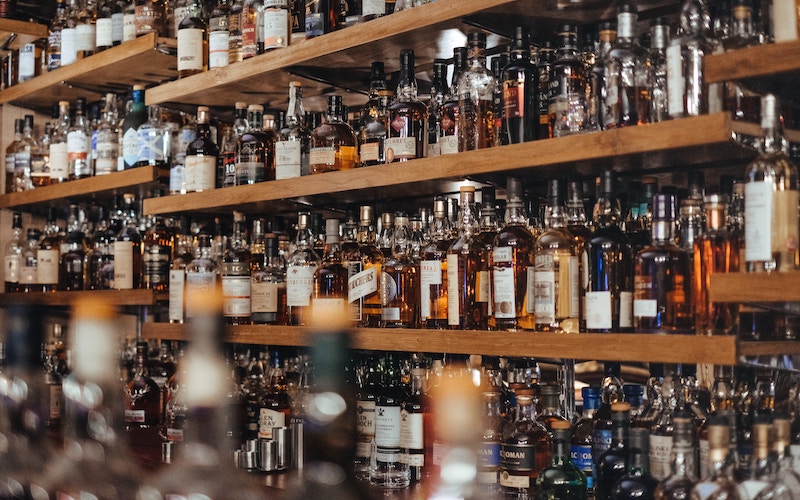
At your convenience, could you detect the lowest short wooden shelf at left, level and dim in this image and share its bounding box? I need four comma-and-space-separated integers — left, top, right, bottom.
0, 290, 162, 307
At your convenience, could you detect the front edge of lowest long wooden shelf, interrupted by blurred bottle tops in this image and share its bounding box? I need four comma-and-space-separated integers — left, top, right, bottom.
142, 323, 744, 365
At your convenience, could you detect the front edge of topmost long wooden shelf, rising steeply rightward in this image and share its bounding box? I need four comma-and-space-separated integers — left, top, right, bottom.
145, 0, 517, 104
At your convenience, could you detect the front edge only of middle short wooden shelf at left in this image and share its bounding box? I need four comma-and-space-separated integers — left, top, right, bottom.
0, 167, 168, 209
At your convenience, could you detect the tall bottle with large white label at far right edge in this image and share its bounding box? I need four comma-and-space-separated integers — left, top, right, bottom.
744, 94, 800, 272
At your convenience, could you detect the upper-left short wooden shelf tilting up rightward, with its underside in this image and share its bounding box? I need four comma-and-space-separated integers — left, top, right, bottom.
0, 33, 178, 115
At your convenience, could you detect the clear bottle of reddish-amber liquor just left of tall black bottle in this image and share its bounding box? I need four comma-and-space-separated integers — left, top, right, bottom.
458, 32, 497, 151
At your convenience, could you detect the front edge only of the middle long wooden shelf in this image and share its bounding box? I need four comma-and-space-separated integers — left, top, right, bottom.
144, 113, 735, 214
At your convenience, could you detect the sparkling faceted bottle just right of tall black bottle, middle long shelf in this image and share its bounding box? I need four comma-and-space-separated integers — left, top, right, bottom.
547, 24, 589, 137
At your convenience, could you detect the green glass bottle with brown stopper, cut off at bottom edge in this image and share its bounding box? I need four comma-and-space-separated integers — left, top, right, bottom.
536, 420, 587, 500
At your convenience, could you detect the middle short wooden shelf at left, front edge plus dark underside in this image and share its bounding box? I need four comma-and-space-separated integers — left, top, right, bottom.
0, 167, 169, 212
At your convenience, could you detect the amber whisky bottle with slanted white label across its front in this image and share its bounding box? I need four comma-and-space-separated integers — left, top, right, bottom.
345, 205, 384, 328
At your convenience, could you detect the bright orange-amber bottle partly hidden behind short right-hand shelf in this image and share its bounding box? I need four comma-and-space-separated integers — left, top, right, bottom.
692, 195, 742, 335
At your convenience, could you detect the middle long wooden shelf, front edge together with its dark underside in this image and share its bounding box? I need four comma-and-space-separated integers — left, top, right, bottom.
144, 113, 755, 218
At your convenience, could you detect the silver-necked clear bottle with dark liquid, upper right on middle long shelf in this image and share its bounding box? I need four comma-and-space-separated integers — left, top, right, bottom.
603, 3, 651, 128
